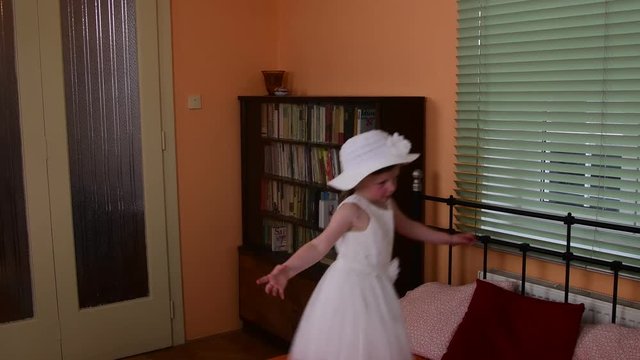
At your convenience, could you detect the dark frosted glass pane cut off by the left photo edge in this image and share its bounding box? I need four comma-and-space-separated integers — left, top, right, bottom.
0, 0, 33, 323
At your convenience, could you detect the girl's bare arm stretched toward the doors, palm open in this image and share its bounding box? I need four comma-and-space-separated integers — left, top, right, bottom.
256, 203, 362, 299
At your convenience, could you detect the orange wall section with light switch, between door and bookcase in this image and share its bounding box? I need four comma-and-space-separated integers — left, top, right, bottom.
171, 0, 277, 340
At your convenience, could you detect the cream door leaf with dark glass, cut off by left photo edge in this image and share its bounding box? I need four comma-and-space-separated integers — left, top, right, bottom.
0, 0, 61, 359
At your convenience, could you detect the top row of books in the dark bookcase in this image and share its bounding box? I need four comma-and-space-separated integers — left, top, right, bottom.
260, 103, 378, 144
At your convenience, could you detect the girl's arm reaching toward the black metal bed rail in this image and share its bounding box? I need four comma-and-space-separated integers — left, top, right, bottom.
391, 200, 476, 245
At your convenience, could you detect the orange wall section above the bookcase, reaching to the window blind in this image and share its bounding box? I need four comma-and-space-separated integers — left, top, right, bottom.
278, 0, 456, 202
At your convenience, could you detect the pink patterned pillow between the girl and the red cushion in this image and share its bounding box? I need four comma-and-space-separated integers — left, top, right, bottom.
400, 281, 517, 360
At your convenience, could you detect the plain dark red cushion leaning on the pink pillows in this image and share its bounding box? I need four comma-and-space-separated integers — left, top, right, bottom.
442, 280, 584, 360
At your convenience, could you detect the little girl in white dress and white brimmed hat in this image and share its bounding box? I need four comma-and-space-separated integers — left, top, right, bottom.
257, 130, 475, 360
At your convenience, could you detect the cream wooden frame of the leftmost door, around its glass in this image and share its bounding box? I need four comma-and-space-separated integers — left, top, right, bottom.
0, 0, 61, 359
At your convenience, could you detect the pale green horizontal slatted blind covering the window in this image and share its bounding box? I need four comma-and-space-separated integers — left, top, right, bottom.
456, 0, 640, 265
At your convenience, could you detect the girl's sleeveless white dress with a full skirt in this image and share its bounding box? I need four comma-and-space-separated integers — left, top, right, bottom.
289, 194, 412, 360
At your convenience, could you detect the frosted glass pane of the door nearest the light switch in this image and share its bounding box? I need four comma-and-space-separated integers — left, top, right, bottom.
61, 0, 149, 308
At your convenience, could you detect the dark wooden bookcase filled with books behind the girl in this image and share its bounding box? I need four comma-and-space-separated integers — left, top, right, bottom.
238, 96, 426, 341
